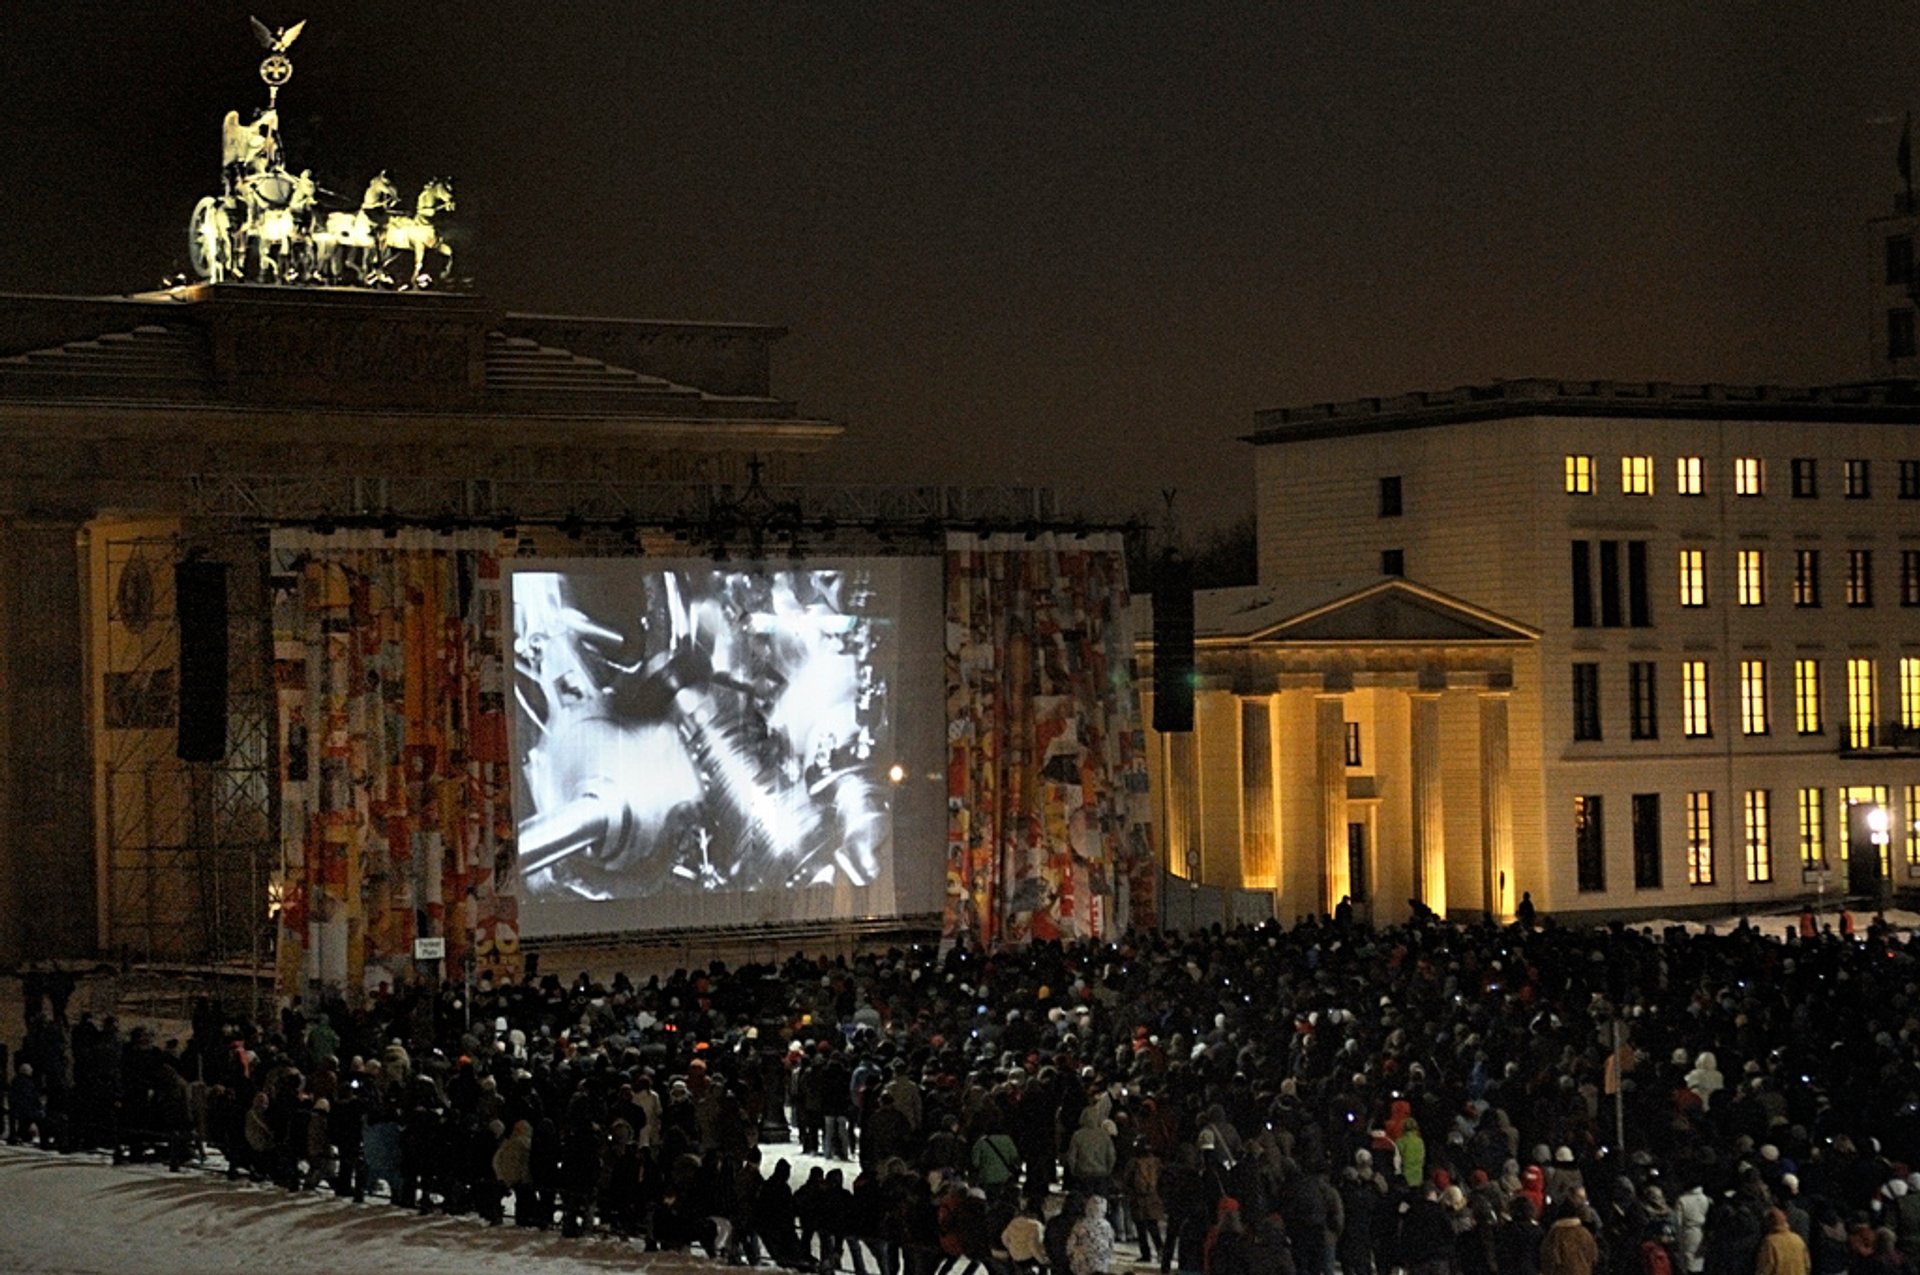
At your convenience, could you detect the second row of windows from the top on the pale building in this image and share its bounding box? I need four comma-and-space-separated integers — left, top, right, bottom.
1566, 540, 1920, 628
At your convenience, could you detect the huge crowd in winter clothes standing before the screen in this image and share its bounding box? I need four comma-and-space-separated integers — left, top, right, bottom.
8, 914, 1920, 1275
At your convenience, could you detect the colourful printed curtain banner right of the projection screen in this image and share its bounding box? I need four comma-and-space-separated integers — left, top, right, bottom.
945, 534, 1158, 943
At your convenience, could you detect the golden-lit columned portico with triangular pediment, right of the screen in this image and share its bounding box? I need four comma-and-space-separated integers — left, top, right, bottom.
1158, 580, 1536, 922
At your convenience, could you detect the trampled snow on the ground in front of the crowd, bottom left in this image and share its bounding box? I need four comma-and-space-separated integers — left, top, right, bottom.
0, 1146, 716, 1275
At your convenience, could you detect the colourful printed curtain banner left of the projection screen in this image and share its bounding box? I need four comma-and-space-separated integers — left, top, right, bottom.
273, 534, 518, 998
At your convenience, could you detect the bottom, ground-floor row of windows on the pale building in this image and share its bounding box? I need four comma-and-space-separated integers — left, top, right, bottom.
1572, 783, 1920, 891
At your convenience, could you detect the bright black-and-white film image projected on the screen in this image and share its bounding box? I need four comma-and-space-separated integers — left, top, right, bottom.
513, 563, 891, 904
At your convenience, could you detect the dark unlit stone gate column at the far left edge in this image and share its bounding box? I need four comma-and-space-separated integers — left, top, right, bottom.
0, 517, 100, 960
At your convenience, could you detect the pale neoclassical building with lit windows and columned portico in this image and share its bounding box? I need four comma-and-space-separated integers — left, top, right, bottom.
1142, 380, 1920, 918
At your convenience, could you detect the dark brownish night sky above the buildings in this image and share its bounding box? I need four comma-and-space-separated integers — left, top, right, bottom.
0, 0, 1920, 532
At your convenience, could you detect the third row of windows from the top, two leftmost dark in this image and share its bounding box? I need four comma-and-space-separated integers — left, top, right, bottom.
1572, 657, 1920, 749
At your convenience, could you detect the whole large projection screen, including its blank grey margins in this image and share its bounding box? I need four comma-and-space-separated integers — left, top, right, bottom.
507, 557, 947, 939
